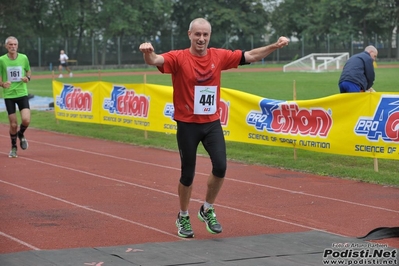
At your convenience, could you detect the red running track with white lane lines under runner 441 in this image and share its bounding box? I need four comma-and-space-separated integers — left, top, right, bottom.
0, 124, 399, 253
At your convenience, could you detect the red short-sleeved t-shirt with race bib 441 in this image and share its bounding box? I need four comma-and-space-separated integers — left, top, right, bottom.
158, 48, 242, 123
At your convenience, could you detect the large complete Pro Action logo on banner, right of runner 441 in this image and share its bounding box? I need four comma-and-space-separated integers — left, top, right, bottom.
247, 99, 332, 137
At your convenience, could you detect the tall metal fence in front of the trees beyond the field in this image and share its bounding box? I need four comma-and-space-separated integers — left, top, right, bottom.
0, 34, 399, 70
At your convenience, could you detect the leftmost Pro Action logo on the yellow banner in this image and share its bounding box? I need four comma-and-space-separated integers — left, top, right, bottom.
56, 84, 93, 112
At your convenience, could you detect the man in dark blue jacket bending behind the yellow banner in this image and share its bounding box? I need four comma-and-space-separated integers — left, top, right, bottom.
338, 45, 378, 93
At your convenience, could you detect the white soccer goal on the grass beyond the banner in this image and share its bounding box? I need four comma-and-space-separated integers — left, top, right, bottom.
283, 53, 349, 72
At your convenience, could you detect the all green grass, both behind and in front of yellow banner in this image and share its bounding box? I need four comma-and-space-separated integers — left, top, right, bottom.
0, 65, 399, 187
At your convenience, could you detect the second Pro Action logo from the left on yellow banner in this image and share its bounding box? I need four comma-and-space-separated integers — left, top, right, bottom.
103, 85, 150, 117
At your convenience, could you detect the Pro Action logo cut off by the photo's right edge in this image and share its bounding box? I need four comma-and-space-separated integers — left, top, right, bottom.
355, 95, 399, 142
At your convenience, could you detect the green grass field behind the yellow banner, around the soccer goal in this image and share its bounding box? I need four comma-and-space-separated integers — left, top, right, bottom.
29, 66, 399, 100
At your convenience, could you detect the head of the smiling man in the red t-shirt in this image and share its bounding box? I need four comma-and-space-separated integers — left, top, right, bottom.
188, 22, 211, 55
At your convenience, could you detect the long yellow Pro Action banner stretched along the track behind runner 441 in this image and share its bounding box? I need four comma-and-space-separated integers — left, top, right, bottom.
53, 81, 399, 160
